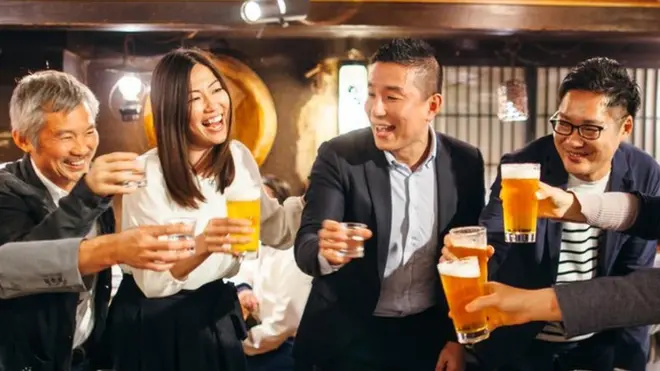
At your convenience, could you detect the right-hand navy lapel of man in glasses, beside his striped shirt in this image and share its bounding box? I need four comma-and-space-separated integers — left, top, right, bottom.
598, 150, 633, 276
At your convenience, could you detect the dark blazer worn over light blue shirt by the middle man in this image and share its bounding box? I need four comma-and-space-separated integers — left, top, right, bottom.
294, 128, 485, 363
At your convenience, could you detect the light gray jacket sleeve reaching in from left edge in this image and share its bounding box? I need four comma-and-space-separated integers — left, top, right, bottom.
0, 238, 93, 299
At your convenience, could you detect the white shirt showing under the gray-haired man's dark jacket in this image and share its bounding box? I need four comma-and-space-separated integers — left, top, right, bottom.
30, 160, 98, 348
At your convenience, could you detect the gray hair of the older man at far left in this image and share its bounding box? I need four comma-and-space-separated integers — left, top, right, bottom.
9, 70, 99, 145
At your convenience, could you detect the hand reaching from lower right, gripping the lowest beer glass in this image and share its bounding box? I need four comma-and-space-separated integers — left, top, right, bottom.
465, 282, 561, 331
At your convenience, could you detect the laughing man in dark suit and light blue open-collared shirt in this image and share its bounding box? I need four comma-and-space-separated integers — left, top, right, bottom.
294, 39, 485, 371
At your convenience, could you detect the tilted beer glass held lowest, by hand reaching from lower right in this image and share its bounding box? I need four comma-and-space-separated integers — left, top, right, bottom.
438, 256, 490, 344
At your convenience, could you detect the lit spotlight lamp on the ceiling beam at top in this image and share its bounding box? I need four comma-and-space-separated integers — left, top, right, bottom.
241, 0, 309, 26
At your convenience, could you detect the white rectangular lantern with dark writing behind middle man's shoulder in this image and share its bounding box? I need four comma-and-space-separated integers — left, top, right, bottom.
337, 60, 370, 135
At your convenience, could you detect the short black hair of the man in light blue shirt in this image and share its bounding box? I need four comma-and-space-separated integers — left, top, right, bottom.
369, 38, 443, 97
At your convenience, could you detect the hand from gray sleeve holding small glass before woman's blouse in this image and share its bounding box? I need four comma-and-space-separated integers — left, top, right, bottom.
107, 224, 195, 271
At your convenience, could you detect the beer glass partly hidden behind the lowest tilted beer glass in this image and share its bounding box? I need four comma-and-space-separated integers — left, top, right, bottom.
447, 226, 488, 282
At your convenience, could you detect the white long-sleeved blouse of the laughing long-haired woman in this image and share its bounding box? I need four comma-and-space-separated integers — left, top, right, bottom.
121, 140, 302, 298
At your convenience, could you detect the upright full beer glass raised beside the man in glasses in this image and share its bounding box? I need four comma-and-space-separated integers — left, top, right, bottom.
500, 163, 541, 243
